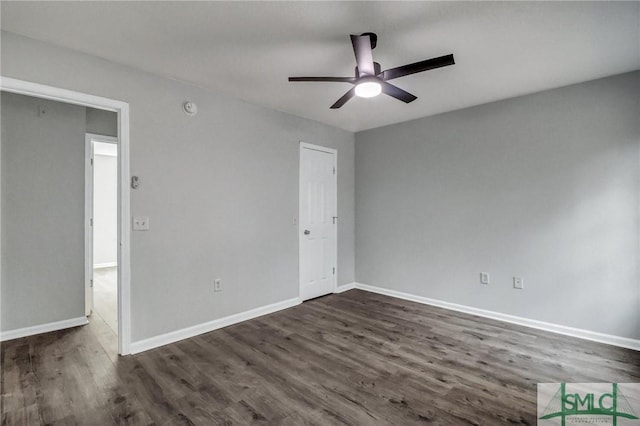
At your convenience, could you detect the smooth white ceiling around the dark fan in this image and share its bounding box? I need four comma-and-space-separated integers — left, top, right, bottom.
2, 1, 640, 131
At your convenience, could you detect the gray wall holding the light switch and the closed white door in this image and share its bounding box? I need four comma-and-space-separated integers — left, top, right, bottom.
1, 33, 354, 341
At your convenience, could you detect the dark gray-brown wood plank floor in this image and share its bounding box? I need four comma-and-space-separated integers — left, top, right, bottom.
1, 290, 640, 426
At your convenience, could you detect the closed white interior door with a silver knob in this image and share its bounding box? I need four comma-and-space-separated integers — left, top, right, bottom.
299, 143, 337, 300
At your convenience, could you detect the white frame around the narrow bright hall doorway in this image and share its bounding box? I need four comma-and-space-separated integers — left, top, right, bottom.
84, 133, 118, 316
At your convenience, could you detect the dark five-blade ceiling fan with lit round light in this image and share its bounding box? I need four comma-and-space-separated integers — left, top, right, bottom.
289, 33, 455, 109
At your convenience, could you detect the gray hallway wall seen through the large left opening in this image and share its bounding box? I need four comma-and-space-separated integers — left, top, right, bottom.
0, 93, 85, 331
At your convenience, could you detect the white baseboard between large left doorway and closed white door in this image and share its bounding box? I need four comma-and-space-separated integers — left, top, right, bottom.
131, 297, 302, 354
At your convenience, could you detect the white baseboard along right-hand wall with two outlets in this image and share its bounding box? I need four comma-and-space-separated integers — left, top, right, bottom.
355, 283, 640, 351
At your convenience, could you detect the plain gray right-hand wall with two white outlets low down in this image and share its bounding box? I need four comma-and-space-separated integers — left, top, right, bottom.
356, 72, 640, 338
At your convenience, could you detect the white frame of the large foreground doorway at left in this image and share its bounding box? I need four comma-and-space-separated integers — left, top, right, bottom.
0, 76, 131, 355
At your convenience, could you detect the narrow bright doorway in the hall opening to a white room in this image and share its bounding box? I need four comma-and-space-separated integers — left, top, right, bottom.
85, 133, 118, 335
